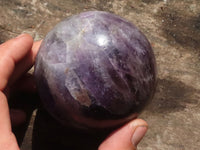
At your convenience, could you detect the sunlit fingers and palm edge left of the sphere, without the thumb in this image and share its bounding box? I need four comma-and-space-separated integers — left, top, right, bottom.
0, 34, 40, 150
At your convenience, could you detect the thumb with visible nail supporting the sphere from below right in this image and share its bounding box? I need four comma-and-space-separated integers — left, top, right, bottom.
99, 119, 148, 150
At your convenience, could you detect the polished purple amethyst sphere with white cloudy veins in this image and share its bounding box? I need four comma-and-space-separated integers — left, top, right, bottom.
34, 11, 156, 128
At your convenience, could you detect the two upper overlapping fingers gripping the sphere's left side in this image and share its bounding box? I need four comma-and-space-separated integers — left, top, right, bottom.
0, 34, 41, 90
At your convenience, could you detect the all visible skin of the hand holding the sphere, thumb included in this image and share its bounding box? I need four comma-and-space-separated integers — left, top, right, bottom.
0, 34, 148, 150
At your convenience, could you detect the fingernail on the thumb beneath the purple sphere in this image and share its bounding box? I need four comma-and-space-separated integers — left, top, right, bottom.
131, 126, 147, 147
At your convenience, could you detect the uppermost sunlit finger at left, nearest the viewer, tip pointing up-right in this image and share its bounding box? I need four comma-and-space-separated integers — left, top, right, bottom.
0, 34, 33, 90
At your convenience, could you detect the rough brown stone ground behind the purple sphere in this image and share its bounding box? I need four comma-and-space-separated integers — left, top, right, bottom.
0, 0, 200, 150
